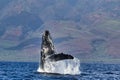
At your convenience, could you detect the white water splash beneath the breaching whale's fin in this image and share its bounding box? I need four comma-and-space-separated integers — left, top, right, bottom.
37, 58, 80, 75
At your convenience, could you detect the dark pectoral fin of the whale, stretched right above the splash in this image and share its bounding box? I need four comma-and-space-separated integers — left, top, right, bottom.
49, 53, 74, 61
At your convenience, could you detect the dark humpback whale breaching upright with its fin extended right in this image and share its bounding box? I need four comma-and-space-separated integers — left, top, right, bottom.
40, 30, 74, 70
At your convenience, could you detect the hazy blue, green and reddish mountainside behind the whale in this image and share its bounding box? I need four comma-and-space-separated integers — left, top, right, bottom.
0, 0, 120, 61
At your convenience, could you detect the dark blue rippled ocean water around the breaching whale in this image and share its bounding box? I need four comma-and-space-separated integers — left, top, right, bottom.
0, 62, 120, 80
